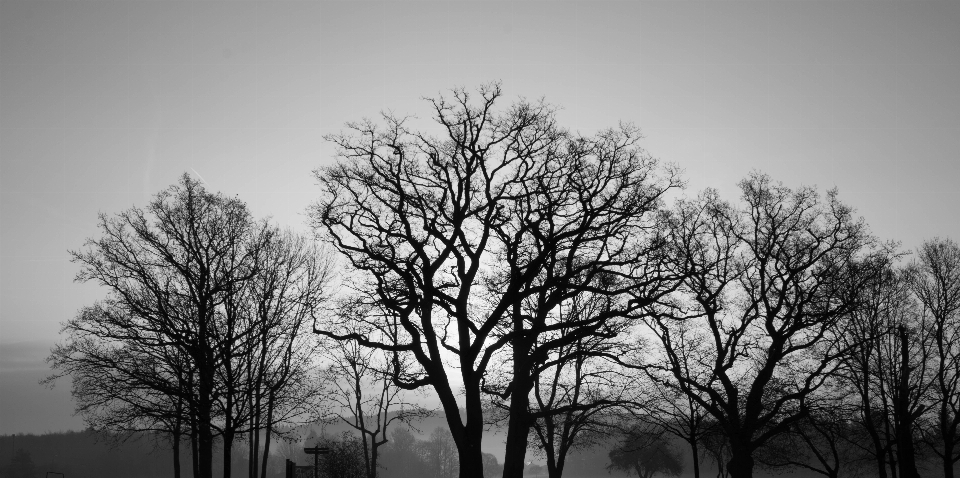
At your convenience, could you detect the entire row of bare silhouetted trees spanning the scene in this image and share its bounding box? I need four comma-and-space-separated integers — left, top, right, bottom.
50, 84, 960, 478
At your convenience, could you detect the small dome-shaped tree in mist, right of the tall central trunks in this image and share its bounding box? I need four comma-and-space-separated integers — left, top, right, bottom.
607, 428, 683, 478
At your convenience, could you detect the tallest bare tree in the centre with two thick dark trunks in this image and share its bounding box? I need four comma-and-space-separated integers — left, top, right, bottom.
313, 86, 678, 478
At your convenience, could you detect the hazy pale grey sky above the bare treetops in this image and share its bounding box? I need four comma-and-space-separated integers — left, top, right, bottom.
0, 0, 960, 433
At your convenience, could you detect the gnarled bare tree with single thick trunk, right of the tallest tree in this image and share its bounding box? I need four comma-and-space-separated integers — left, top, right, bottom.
651, 174, 871, 478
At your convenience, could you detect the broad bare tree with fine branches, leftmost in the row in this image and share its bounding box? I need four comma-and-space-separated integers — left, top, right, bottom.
50, 175, 330, 478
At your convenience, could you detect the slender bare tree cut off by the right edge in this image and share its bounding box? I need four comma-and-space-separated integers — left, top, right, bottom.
910, 239, 960, 478
